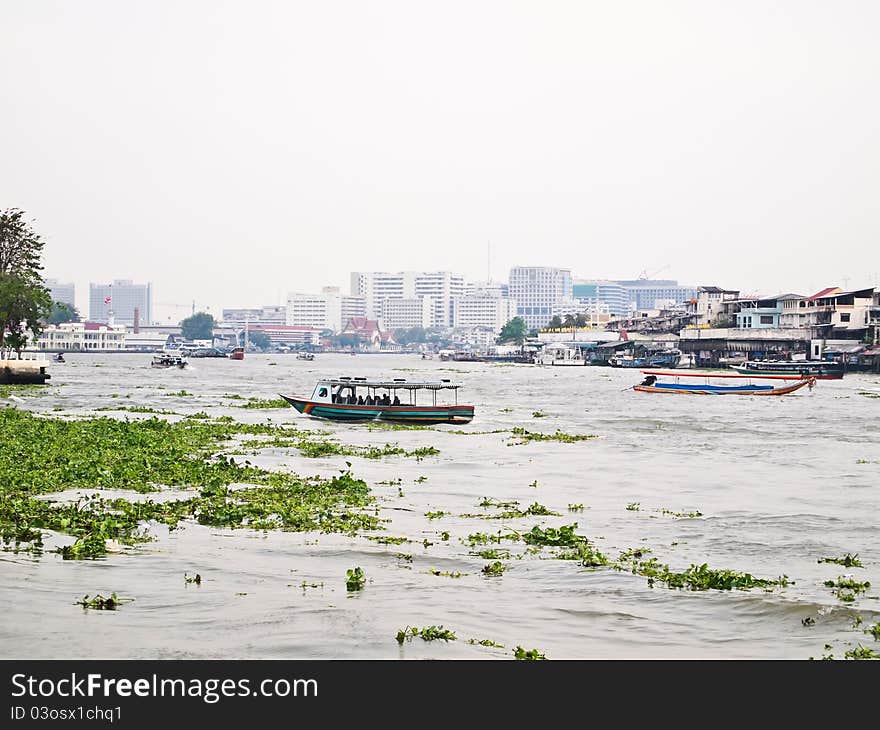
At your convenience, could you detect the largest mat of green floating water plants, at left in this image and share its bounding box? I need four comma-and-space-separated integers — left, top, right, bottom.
0, 408, 381, 559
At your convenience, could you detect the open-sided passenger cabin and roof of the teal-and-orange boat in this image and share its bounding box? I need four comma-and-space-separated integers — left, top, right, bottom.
311, 377, 461, 406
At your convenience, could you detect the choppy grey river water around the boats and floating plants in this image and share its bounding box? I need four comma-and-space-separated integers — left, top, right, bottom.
0, 354, 880, 659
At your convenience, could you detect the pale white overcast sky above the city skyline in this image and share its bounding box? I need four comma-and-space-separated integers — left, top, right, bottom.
0, 0, 880, 322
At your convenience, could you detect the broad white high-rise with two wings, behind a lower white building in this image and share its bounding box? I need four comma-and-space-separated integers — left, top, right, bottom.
351, 271, 465, 327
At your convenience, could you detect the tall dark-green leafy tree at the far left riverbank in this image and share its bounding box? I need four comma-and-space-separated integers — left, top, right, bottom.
0, 208, 52, 359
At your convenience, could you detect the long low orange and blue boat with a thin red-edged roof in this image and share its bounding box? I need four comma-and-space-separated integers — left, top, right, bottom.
633, 370, 816, 395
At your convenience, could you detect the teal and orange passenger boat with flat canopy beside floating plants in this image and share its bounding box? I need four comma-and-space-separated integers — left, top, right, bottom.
281, 377, 474, 424
